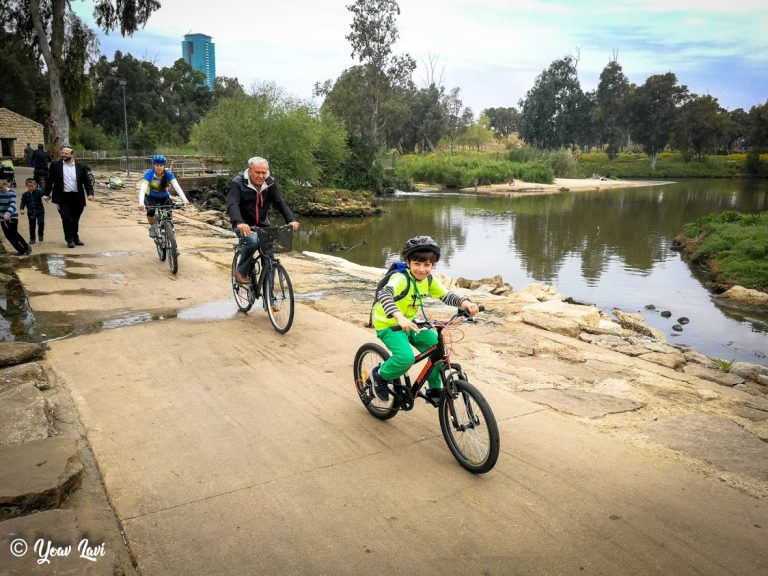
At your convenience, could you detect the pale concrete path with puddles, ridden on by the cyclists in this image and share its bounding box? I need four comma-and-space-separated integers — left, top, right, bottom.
6, 180, 768, 576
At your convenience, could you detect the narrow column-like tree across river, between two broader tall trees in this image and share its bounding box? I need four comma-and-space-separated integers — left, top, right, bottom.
594, 58, 629, 161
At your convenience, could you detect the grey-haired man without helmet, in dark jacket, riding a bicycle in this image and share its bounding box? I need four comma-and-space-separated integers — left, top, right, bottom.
227, 156, 299, 284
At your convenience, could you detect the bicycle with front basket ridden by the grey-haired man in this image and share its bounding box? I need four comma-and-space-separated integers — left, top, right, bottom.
231, 226, 294, 334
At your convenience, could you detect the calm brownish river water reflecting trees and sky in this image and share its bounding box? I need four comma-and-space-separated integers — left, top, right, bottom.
293, 180, 768, 365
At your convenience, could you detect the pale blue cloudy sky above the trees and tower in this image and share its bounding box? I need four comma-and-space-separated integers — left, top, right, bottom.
72, 0, 768, 115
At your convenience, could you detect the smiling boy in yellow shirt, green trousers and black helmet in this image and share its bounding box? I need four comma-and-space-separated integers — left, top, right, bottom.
372, 236, 479, 402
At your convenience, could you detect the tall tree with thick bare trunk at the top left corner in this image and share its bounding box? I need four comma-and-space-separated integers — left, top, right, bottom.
7, 0, 160, 152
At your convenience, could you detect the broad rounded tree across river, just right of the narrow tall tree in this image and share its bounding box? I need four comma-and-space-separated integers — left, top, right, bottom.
628, 72, 688, 170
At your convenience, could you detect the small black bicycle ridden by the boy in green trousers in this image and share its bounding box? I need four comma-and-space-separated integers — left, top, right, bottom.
353, 306, 499, 474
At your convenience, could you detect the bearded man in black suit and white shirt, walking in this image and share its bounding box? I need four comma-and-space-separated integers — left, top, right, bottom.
44, 145, 93, 248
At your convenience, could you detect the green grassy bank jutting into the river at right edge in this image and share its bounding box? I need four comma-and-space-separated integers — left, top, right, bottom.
677, 210, 768, 292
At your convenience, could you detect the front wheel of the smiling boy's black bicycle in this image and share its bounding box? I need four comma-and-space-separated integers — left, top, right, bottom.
438, 380, 499, 474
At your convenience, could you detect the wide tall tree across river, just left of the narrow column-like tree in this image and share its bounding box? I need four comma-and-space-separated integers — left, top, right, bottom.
519, 56, 583, 150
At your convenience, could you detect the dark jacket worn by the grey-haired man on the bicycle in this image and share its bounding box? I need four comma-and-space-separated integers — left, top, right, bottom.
227, 174, 296, 227
